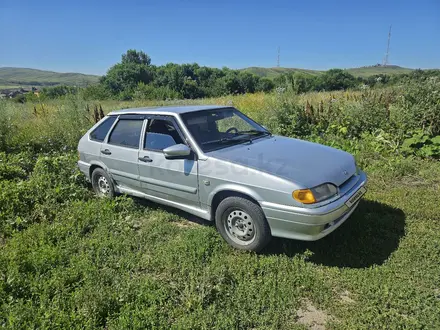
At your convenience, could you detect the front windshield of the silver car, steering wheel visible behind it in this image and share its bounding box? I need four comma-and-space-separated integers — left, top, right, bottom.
182, 108, 270, 152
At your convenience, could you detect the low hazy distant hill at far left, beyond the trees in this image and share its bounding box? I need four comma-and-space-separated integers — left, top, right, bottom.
0, 67, 99, 89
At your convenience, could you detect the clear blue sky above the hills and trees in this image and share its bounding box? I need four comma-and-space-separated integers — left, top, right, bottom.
0, 0, 440, 74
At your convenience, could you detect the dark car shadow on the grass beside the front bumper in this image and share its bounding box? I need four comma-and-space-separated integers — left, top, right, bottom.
262, 200, 405, 268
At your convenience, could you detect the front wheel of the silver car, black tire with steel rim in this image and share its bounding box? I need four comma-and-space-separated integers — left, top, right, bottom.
215, 196, 272, 252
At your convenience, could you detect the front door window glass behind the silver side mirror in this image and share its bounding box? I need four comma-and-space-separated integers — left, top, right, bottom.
144, 119, 184, 151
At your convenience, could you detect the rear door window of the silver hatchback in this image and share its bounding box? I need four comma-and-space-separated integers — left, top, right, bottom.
108, 119, 143, 148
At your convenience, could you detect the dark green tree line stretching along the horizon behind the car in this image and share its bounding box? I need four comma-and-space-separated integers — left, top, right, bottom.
23, 49, 440, 100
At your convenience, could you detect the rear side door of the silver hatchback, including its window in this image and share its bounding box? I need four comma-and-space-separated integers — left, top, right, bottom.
100, 115, 144, 190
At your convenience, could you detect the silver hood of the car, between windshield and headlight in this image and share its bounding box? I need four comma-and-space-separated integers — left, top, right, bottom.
207, 136, 356, 188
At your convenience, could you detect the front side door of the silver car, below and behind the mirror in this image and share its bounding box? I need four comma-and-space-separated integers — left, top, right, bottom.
139, 116, 199, 206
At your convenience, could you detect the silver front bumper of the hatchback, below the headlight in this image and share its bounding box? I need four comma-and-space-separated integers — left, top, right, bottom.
261, 172, 367, 241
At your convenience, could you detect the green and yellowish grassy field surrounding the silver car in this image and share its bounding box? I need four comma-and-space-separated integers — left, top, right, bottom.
0, 85, 440, 329
